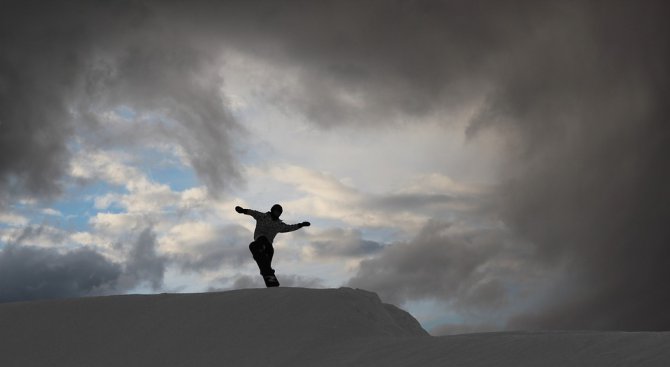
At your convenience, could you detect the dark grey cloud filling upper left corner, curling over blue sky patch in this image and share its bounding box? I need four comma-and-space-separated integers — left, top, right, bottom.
0, 1, 244, 202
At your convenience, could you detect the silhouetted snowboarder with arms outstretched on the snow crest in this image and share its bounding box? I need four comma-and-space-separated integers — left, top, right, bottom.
235, 204, 310, 287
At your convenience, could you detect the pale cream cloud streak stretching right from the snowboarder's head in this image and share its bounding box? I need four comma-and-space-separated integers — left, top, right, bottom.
256, 164, 487, 232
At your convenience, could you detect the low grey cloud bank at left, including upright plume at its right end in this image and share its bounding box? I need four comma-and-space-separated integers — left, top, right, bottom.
0, 226, 169, 302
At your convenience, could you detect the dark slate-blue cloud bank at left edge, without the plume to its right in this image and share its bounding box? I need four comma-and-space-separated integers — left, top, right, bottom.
0, 244, 121, 302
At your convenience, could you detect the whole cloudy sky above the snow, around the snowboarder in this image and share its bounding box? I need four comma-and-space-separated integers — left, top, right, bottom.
0, 0, 670, 335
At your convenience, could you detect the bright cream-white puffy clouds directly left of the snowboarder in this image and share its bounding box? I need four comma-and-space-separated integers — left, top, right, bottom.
70, 150, 252, 282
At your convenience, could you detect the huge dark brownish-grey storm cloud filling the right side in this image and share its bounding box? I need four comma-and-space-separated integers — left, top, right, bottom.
473, 2, 670, 330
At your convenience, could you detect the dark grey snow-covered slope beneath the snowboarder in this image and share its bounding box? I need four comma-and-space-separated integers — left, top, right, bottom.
0, 288, 670, 367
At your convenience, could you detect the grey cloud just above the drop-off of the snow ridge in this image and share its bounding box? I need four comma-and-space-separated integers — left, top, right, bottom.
349, 221, 547, 323
